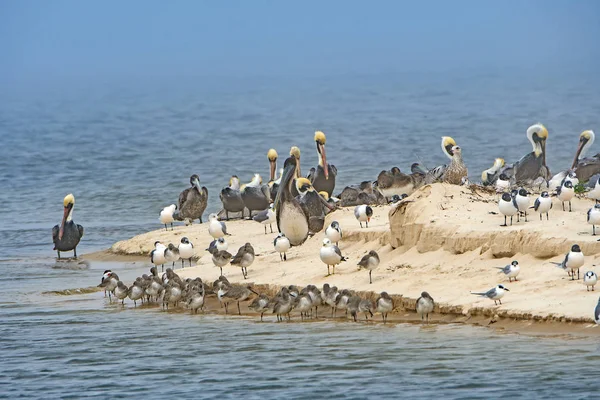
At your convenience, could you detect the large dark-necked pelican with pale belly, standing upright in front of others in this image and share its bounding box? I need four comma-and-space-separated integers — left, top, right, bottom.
275, 156, 309, 246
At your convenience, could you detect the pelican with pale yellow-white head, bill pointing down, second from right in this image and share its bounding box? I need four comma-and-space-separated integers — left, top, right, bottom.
502, 123, 551, 185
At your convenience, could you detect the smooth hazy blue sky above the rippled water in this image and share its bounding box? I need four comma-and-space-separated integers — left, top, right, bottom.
0, 0, 600, 81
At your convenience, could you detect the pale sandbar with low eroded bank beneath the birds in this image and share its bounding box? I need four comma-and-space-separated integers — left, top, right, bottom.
86, 184, 600, 334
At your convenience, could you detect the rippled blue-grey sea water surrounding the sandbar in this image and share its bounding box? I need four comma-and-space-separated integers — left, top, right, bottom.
0, 72, 600, 398
